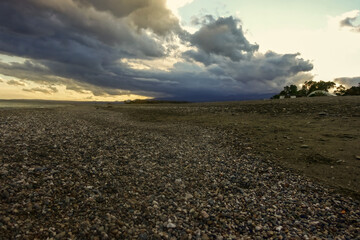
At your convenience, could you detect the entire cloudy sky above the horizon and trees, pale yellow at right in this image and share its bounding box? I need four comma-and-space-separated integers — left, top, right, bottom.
0, 0, 360, 101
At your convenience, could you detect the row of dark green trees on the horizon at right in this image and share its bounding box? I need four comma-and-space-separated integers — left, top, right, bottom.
272, 80, 360, 99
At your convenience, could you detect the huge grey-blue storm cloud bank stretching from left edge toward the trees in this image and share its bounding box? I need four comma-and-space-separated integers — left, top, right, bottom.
0, 0, 313, 100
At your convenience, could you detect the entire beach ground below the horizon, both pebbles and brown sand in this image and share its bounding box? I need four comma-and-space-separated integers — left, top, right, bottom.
0, 97, 360, 239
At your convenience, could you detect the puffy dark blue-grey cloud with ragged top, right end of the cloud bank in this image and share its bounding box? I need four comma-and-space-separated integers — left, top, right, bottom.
184, 16, 313, 92
